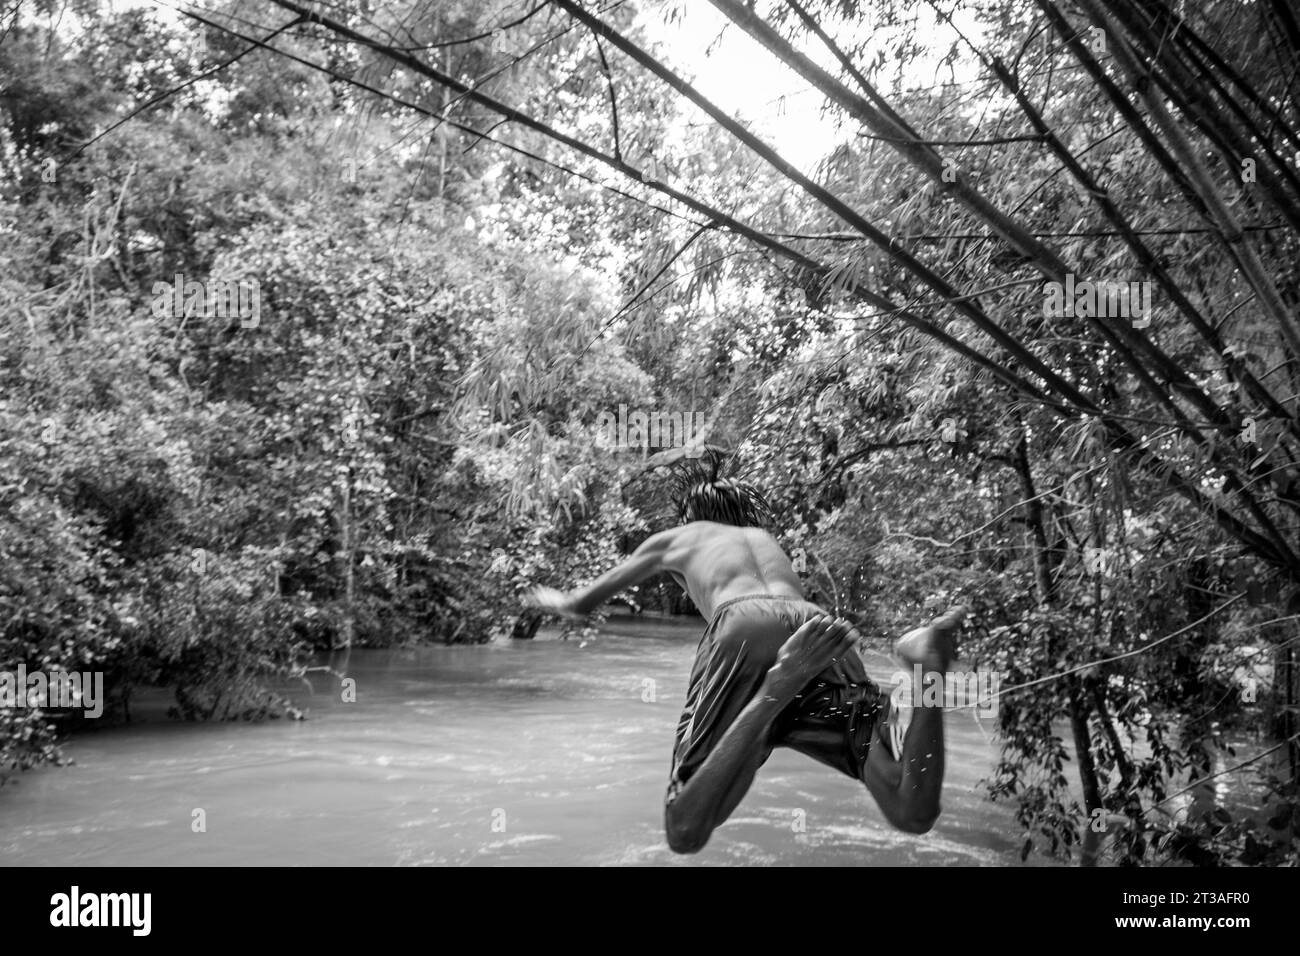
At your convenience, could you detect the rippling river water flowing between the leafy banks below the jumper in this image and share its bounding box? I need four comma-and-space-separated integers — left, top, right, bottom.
0, 619, 1019, 866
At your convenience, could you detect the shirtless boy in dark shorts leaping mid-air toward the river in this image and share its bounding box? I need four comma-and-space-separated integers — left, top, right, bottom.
529, 479, 966, 853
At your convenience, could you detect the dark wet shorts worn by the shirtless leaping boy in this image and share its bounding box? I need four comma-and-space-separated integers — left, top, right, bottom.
667, 594, 889, 804
